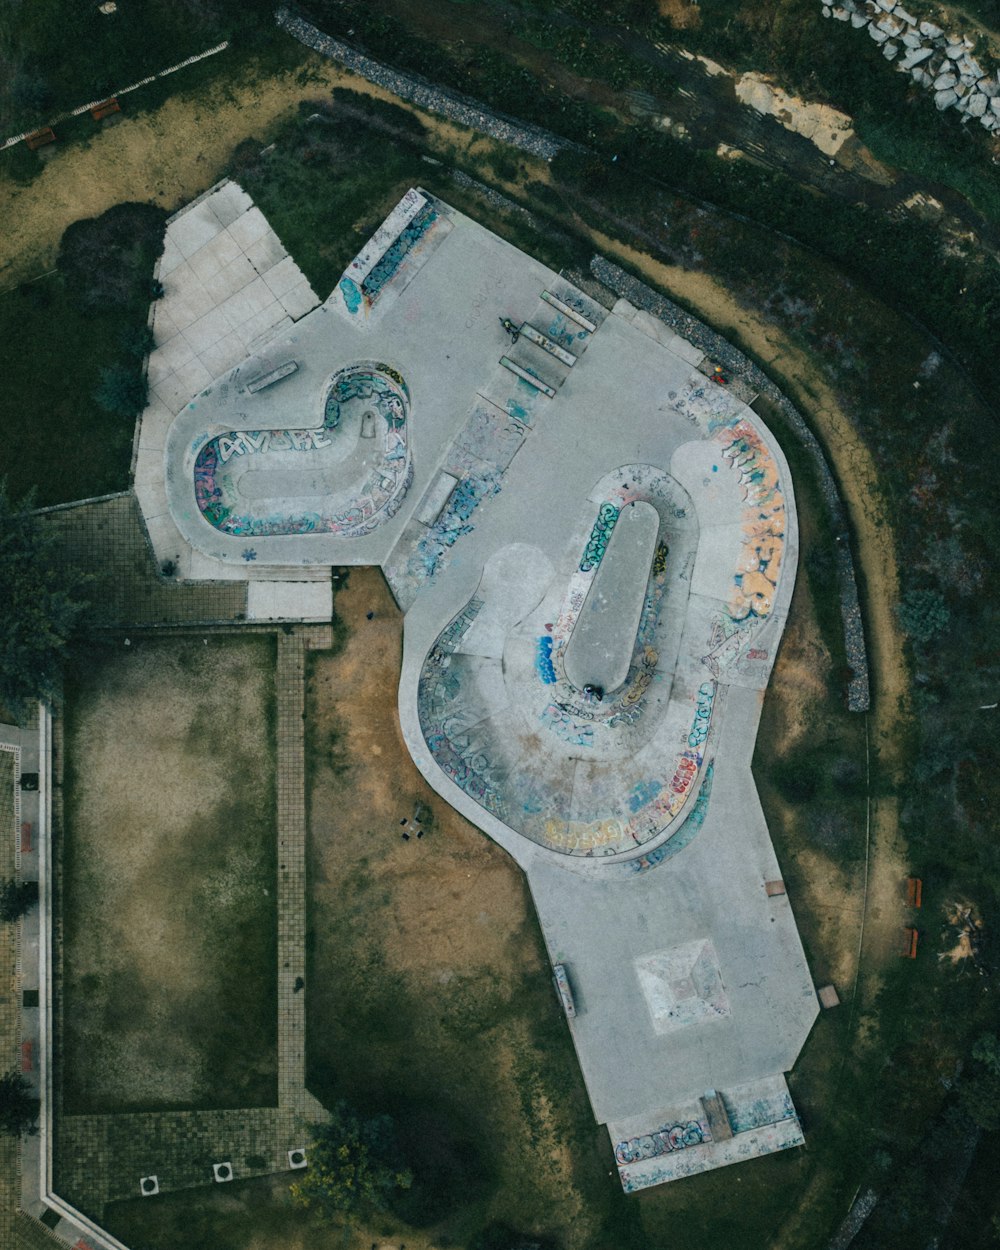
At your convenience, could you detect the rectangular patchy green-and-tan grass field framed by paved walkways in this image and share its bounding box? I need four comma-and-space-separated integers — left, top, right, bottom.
59, 636, 278, 1113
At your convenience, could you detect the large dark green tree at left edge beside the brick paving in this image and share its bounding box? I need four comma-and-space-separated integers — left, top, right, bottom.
0, 479, 84, 716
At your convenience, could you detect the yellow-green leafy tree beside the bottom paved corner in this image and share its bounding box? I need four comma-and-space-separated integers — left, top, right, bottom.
291, 1103, 413, 1220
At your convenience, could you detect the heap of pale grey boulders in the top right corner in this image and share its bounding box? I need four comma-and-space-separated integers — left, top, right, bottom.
823, 0, 1000, 134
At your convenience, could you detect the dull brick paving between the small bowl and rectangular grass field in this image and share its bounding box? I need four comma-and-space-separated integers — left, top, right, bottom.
39, 491, 246, 629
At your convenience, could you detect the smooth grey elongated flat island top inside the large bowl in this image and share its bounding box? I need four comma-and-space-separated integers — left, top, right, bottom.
564, 499, 660, 693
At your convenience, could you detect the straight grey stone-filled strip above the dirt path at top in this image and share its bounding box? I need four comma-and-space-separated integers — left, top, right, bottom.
276, 9, 578, 160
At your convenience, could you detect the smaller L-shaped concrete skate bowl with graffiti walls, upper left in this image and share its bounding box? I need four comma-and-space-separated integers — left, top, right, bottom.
194, 360, 413, 538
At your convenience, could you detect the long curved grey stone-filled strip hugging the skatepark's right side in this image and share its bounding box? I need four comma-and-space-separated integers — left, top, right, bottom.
590, 256, 871, 711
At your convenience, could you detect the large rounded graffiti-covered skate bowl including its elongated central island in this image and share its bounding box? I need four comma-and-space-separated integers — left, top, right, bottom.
418, 465, 735, 856
